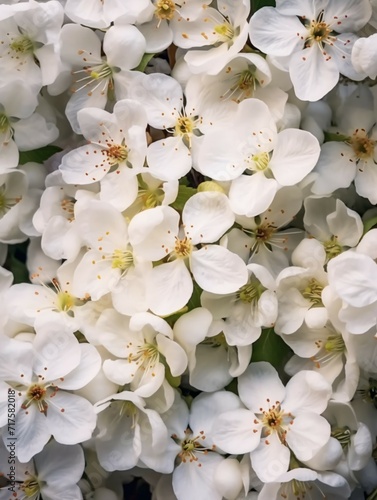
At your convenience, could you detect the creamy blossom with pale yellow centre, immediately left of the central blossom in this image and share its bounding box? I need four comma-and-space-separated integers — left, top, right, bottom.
72, 200, 151, 314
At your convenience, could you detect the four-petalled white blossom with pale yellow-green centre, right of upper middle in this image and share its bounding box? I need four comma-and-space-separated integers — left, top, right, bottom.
198, 99, 320, 217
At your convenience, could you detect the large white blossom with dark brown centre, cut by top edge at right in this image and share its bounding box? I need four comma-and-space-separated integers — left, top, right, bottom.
250, 0, 372, 101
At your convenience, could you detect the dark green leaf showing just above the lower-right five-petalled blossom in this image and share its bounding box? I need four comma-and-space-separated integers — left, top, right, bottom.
251, 328, 293, 381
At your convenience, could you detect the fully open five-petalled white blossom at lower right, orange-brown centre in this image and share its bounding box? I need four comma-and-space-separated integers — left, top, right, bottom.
213, 361, 331, 482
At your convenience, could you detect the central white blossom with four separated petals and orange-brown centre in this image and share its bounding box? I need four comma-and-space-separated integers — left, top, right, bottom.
129, 191, 247, 315
